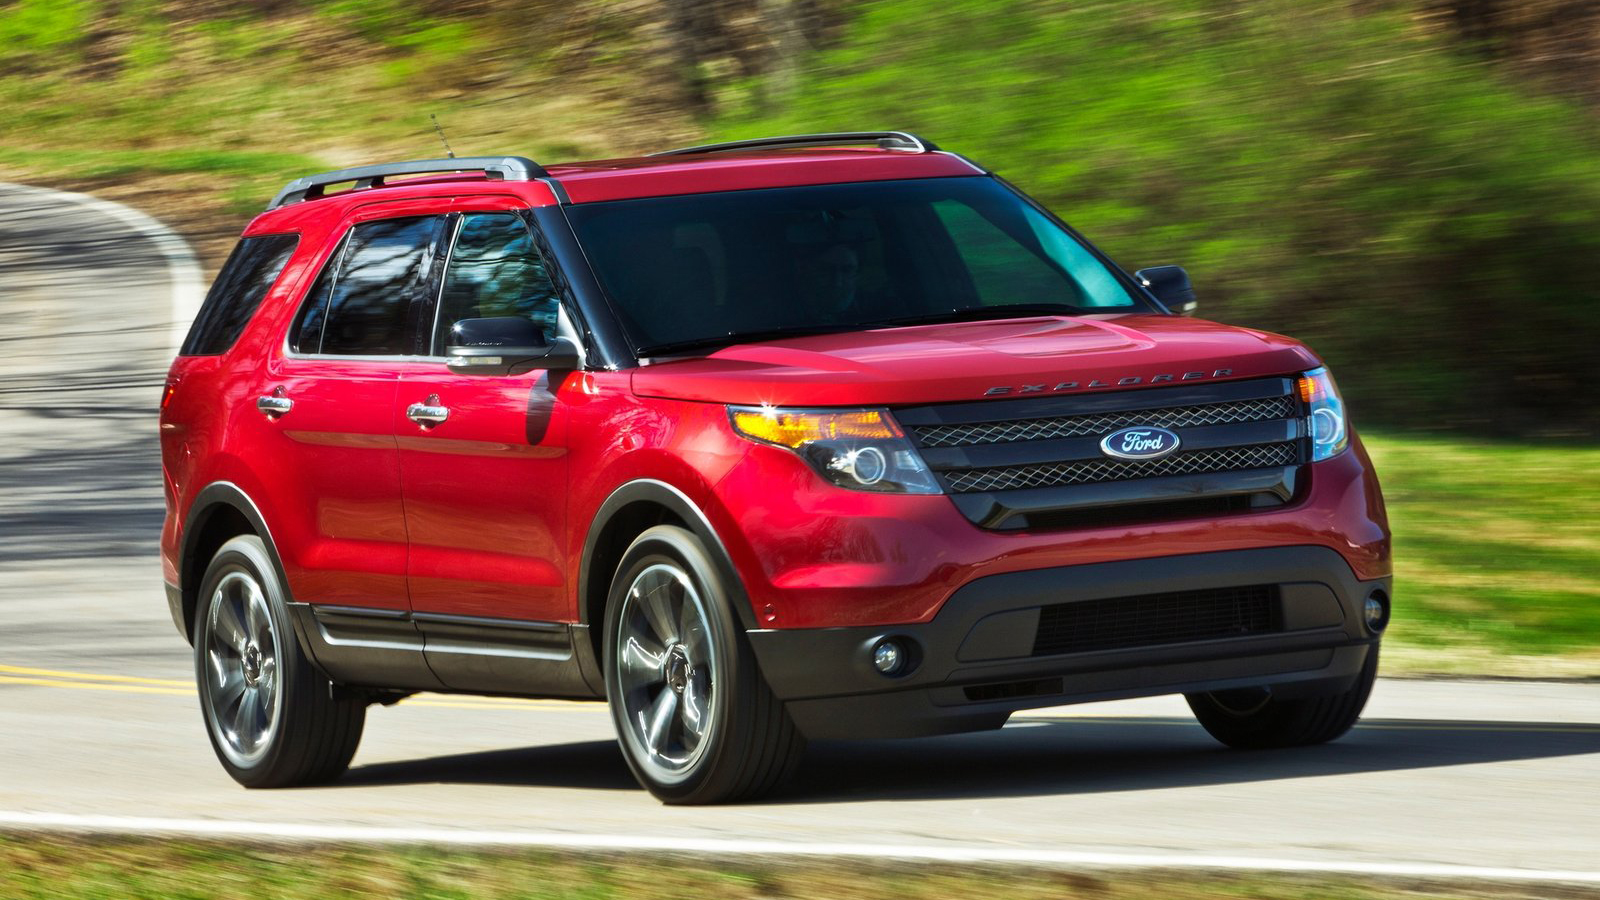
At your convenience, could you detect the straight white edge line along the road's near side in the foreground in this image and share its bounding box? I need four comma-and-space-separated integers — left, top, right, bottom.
0, 812, 1600, 884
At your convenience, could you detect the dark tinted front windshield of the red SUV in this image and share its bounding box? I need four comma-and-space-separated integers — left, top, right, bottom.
568, 176, 1152, 356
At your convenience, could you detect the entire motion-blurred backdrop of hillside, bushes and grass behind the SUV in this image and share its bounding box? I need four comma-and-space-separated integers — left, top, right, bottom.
0, 0, 1600, 673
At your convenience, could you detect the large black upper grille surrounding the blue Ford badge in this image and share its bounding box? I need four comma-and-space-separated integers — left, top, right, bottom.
894, 376, 1310, 532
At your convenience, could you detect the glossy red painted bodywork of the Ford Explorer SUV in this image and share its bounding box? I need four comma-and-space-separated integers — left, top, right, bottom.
162, 151, 1390, 628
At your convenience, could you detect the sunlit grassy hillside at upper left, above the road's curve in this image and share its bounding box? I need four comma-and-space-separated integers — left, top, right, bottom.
0, 0, 701, 267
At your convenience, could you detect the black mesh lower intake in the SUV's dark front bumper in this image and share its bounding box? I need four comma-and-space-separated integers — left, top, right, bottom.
1034, 585, 1283, 657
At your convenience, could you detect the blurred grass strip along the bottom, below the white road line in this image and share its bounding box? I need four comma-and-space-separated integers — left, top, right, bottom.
0, 834, 1600, 900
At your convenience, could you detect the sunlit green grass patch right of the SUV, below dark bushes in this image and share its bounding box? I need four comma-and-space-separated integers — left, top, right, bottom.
1365, 434, 1600, 674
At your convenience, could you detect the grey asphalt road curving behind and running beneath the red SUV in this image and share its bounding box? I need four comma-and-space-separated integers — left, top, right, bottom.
0, 187, 1600, 879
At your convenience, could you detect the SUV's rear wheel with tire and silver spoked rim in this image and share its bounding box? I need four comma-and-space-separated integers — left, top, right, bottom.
194, 535, 366, 788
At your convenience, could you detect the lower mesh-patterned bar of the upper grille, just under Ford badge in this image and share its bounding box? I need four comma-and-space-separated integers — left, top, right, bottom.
944, 440, 1299, 493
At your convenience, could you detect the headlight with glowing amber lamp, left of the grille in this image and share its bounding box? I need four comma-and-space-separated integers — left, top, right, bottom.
728, 407, 939, 493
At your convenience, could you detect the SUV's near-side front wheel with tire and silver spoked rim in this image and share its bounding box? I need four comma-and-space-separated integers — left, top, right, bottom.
605, 525, 805, 804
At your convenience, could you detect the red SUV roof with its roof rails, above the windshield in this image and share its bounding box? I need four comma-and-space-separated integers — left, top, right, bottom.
245, 133, 984, 234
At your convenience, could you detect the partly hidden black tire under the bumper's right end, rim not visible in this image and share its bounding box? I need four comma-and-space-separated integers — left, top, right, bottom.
1184, 645, 1378, 749
